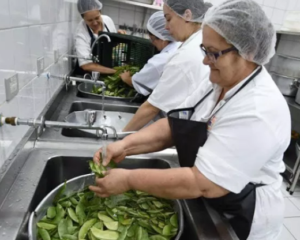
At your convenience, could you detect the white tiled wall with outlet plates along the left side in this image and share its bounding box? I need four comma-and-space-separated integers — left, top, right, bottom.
0, 0, 80, 167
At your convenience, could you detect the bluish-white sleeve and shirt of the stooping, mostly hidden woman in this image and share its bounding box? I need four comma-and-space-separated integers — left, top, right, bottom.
132, 42, 181, 96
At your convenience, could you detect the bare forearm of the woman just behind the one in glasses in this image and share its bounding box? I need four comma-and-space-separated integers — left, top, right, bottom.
123, 101, 160, 132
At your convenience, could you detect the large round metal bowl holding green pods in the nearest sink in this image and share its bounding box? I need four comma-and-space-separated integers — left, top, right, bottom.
28, 173, 184, 240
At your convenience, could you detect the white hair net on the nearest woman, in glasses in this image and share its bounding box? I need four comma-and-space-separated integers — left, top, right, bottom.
203, 0, 276, 65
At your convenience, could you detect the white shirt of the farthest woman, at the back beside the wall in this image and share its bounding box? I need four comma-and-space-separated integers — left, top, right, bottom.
75, 15, 117, 66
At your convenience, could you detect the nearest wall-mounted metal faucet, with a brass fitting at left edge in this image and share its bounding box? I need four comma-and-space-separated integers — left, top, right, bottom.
0, 115, 118, 140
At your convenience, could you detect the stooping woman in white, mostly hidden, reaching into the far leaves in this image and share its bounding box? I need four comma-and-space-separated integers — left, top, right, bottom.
120, 11, 181, 96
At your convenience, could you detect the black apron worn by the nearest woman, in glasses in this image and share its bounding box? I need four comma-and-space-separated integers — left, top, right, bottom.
168, 67, 263, 240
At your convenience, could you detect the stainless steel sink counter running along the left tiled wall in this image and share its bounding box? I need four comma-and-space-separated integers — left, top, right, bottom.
0, 84, 238, 240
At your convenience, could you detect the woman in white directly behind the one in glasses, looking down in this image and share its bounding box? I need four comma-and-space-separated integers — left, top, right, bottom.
123, 0, 211, 132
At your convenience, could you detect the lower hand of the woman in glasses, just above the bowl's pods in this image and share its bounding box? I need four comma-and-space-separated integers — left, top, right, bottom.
89, 169, 130, 198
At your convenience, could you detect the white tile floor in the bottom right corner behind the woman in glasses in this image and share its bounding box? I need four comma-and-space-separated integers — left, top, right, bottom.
279, 183, 300, 240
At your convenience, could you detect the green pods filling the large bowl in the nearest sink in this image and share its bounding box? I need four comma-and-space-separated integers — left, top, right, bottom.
37, 161, 178, 240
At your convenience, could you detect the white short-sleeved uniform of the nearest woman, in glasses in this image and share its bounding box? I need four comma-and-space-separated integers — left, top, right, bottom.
180, 68, 291, 240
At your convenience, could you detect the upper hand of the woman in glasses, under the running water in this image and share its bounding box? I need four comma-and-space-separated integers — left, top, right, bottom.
93, 141, 126, 166
